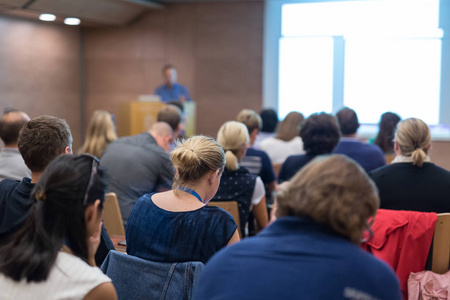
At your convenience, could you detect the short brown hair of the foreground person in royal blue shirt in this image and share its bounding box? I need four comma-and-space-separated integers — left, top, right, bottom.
276, 155, 380, 244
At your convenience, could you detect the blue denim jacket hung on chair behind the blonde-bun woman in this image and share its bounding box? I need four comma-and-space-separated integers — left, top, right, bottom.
100, 250, 204, 300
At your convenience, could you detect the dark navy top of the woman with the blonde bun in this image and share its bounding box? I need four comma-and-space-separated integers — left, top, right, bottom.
126, 193, 237, 263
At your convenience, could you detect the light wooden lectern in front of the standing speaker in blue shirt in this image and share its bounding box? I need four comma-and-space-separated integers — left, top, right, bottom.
117, 101, 195, 137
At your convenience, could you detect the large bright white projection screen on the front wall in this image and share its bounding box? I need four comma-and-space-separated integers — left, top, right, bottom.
278, 0, 443, 124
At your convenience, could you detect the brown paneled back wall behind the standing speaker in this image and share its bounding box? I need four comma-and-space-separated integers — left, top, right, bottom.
84, 1, 263, 136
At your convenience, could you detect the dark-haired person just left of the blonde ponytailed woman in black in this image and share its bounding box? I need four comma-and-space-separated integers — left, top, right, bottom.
374, 112, 401, 154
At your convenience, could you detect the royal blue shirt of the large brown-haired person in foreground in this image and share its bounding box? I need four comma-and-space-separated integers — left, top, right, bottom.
194, 217, 401, 300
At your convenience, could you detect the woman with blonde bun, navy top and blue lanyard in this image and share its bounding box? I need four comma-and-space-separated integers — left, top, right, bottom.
126, 136, 239, 263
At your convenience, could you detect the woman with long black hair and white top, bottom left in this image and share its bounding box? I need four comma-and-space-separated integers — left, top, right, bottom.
0, 155, 117, 300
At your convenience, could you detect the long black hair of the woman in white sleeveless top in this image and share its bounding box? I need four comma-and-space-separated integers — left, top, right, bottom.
0, 155, 106, 282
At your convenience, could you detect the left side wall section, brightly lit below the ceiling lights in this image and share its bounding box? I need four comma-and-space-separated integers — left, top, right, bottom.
0, 16, 81, 148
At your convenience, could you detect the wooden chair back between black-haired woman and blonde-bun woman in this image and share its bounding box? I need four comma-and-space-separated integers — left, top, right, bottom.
103, 193, 125, 236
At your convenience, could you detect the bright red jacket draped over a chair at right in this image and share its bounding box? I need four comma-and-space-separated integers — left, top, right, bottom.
362, 209, 437, 299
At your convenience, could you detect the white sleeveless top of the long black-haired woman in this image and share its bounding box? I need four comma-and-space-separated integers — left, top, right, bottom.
0, 252, 111, 300
